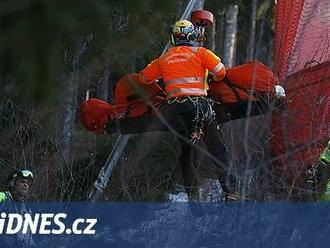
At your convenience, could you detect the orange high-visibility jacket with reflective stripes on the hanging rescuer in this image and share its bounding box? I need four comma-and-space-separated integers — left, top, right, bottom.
140, 46, 226, 99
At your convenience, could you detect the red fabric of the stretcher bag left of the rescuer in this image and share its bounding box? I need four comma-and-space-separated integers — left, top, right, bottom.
80, 74, 165, 133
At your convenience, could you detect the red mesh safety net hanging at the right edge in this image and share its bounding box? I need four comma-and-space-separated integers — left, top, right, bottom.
271, 0, 330, 182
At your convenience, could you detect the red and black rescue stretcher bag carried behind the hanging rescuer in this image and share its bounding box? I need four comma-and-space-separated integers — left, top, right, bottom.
80, 61, 285, 134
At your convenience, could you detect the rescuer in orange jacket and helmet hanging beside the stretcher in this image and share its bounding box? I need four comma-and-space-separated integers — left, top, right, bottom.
140, 20, 235, 201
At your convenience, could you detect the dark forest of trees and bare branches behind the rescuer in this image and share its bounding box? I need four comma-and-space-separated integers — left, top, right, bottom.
0, 0, 276, 201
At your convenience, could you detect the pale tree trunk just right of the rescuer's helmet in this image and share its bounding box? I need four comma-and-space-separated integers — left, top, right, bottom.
223, 5, 238, 68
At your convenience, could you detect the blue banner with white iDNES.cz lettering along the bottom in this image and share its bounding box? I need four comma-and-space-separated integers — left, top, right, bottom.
0, 202, 330, 248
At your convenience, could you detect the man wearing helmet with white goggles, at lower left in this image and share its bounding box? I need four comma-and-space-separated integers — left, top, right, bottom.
0, 170, 33, 203
